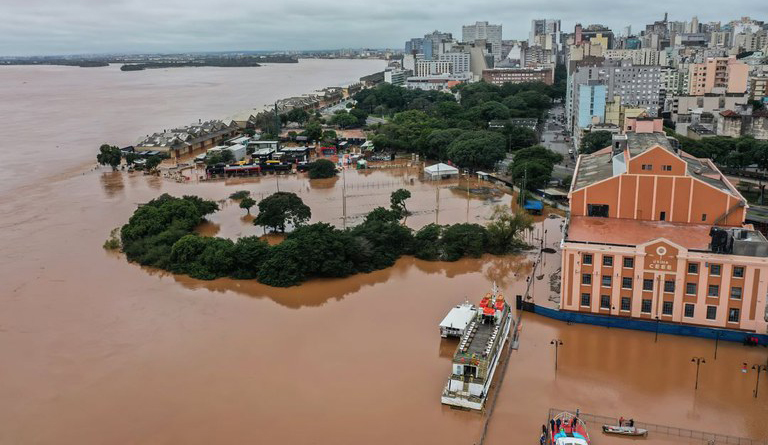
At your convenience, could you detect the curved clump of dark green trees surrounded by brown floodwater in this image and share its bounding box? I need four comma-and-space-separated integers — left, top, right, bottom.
120, 190, 531, 287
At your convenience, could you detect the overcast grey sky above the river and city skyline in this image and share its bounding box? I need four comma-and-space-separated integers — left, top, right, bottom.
0, 0, 768, 55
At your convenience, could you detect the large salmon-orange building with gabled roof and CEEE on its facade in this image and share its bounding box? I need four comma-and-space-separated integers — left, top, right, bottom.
560, 118, 768, 334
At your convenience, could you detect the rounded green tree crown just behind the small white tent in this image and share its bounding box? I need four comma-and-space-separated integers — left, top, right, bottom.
447, 131, 506, 169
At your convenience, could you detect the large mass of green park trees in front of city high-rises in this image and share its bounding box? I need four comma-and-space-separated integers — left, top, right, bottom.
350, 82, 555, 162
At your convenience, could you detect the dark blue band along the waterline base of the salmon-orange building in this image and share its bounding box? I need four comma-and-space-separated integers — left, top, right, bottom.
523, 303, 768, 345
